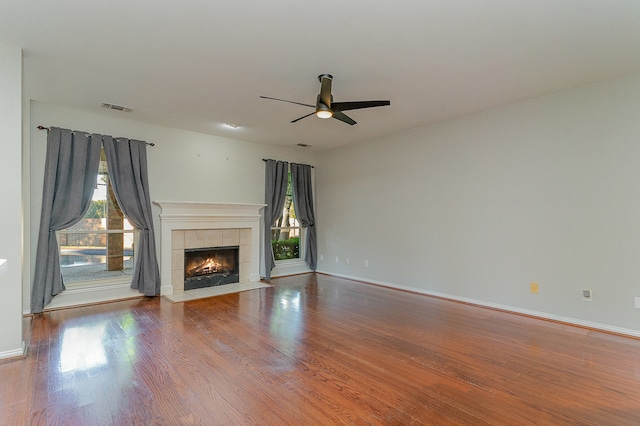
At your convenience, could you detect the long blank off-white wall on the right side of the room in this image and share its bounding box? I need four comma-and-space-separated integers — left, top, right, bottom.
316, 74, 640, 334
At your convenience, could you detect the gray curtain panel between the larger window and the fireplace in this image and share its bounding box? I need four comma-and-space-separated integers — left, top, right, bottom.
103, 136, 160, 296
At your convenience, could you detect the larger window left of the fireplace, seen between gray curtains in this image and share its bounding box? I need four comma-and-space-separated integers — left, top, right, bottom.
58, 150, 135, 286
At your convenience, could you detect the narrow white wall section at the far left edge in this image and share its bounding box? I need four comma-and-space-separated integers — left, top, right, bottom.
0, 43, 24, 358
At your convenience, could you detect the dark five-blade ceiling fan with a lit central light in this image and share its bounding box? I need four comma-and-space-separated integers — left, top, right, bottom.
260, 74, 391, 126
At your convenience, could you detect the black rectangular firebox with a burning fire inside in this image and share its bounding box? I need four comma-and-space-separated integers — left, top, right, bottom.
184, 246, 240, 290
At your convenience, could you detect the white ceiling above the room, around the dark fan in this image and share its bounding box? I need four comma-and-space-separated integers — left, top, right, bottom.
0, 0, 640, 150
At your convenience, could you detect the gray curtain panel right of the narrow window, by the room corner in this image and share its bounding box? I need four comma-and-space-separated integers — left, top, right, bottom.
291, 163, 318, 271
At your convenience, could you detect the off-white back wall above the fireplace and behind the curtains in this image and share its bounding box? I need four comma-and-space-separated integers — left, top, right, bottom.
24, 102, 313, 310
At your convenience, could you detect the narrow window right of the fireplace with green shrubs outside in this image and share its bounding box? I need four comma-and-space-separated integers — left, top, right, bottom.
271, 171, 301, 261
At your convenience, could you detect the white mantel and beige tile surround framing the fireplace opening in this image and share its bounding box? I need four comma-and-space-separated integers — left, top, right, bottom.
153, 201, 264, 294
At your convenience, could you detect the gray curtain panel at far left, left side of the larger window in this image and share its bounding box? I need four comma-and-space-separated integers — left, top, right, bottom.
31, 127, 102, 314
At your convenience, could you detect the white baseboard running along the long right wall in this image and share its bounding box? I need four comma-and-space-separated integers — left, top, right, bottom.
316, 271, 640, 338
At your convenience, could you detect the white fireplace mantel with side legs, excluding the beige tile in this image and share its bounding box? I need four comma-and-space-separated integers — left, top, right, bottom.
153, 201, 265, 294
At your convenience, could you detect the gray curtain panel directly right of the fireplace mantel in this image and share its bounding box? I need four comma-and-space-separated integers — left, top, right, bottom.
263, 160, 289, 280
